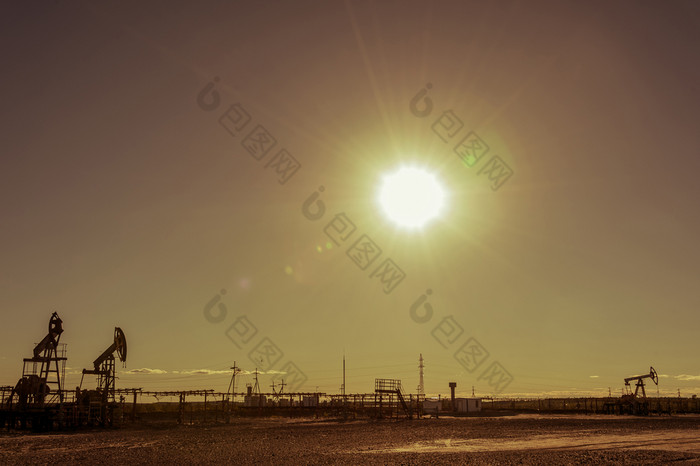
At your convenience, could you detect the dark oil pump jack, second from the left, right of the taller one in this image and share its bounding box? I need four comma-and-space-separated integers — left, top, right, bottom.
77, 327, 126, 425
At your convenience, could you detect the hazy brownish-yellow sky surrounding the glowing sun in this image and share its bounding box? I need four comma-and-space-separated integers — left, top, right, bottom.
0, 1, 700, 395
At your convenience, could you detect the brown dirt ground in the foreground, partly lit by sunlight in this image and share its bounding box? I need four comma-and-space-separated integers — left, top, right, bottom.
0, 415, 700, 465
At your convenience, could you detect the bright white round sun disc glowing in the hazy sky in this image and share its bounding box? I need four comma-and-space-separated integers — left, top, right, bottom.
379, 167, 445, 229
